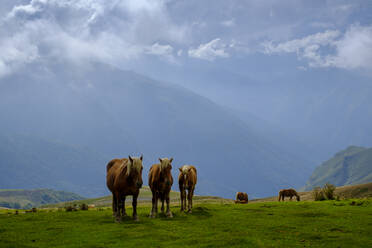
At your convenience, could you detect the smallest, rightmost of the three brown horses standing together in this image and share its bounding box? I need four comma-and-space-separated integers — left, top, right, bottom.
178, 165, 197, 213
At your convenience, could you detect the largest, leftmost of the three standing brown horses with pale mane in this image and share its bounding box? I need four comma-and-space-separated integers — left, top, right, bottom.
106, 155, 143, 222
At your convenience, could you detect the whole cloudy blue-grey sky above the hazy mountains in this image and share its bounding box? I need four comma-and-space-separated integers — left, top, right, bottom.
0, 0, 372, 77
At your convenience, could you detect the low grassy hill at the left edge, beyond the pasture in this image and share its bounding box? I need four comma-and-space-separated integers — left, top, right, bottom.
0, 189, 84, 209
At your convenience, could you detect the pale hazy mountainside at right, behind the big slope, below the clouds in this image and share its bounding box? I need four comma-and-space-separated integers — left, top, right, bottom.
141, 60, 372, 164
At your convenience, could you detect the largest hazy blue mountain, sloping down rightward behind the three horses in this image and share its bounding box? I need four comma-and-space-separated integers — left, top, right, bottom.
0, 61, 311, 197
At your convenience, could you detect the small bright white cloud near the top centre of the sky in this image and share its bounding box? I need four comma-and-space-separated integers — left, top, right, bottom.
188, 38, 229, 61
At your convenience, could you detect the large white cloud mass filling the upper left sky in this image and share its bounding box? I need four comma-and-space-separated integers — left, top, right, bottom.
0, 0, 187, 74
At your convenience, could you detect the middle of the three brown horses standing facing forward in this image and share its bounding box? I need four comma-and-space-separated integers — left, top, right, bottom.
149, 158, 173, 218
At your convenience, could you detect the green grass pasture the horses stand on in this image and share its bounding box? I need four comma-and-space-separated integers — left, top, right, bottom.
0, 199, 372, 248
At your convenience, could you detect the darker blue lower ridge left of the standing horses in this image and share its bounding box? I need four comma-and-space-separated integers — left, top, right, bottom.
0, 135, 107, 196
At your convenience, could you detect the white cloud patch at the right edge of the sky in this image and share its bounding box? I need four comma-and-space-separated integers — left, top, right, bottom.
263, 25, 372, 69
